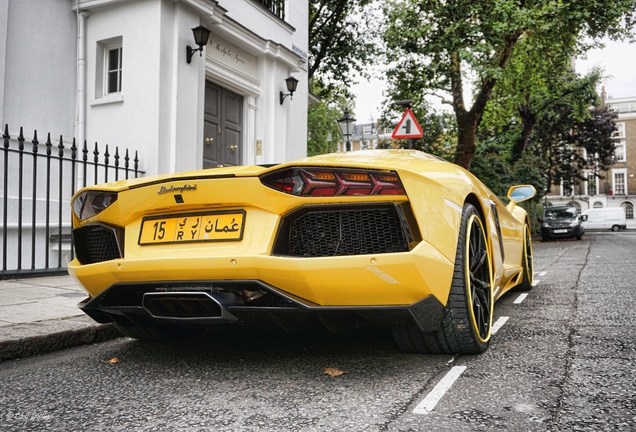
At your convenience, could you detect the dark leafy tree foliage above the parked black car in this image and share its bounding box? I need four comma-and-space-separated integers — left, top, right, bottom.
473, 67, 616, 195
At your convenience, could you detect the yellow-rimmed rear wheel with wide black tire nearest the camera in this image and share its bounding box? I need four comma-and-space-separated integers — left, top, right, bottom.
392, 203, 494, 354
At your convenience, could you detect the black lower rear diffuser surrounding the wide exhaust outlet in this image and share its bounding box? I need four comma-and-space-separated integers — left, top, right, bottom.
80, 280, 444, 331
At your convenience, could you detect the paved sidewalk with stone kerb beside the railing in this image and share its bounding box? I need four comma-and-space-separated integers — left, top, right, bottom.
0, 275, 121, 362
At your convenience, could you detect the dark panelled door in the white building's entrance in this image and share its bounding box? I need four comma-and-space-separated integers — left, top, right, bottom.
203, 82, 243, 168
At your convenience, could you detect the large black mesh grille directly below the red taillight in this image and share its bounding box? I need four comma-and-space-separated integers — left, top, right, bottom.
274, 205, 409, 257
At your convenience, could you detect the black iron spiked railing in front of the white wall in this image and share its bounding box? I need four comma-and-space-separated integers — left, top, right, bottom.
0, 125, 144, 278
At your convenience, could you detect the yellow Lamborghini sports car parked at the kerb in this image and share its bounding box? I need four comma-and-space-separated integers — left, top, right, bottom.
69, 150, 535, 353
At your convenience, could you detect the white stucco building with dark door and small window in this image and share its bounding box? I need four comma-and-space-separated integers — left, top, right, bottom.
0, 0, 308, 175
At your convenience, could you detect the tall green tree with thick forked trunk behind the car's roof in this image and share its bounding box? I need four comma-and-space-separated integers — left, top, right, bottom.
384, 0, 636, 168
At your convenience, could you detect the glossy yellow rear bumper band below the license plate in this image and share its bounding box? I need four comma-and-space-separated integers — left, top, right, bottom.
68, 241, 453, 307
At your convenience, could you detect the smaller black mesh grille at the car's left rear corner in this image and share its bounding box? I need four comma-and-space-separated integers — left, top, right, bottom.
73, 225, 121, 264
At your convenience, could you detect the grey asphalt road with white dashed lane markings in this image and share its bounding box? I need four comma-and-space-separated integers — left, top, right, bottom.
0, 232, 636, 431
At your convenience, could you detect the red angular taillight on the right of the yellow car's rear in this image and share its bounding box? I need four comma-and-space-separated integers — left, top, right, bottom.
261, 168, 406, 196
